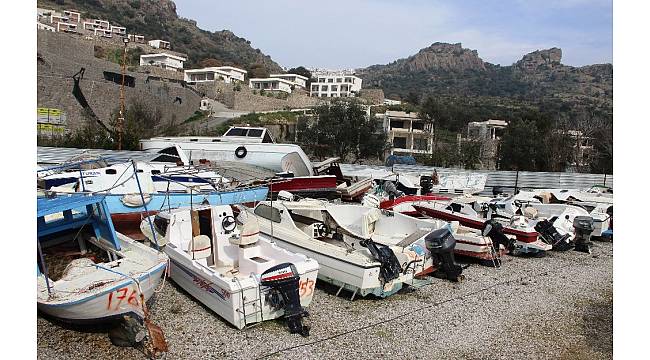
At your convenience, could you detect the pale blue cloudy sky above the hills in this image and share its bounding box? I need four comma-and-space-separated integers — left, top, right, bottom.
175, 0, 613, 69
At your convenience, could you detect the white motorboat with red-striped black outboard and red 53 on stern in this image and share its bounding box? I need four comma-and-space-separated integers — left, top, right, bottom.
140, 205, 318, 335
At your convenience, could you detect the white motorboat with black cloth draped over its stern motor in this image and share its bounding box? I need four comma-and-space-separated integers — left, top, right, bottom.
239, 199, 461, 298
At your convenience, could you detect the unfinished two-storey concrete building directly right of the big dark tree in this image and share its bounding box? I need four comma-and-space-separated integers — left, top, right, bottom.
384, 111, 433, 155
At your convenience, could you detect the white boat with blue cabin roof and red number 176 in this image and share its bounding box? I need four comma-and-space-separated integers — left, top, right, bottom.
37, 195, 168, 323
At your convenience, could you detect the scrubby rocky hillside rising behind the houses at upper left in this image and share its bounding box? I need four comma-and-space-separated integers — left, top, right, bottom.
38, 0, 281, 72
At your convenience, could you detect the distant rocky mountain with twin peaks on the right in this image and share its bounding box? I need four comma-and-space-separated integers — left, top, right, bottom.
357, 43, 613, 118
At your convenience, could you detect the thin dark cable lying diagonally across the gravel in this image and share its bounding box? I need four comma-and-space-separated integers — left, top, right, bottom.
256, 252, 591, 359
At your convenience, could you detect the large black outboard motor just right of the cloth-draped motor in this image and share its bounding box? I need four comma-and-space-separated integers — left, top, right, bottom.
424, 228, 465, 281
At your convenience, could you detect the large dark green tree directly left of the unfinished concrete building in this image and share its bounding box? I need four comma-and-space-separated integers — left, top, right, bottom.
297, 100, 388, 162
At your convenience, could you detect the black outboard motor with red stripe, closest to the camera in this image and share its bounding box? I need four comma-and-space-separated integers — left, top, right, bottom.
260, 263, 309, 336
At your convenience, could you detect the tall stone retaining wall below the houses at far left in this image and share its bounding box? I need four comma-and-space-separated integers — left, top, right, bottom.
36, 30, 201, 130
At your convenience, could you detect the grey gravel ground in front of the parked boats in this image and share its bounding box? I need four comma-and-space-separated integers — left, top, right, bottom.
37, 242, 613, 360
